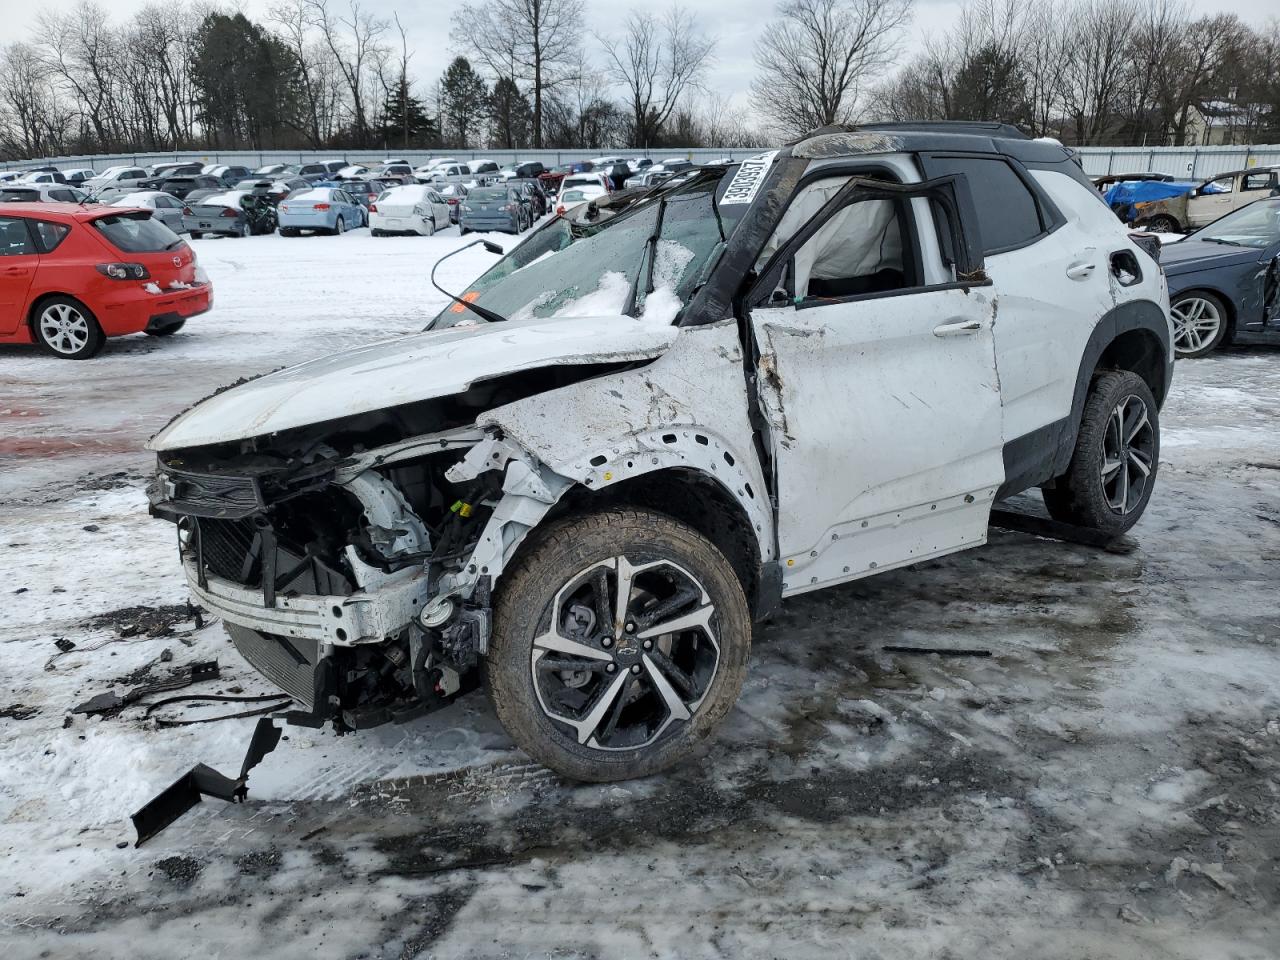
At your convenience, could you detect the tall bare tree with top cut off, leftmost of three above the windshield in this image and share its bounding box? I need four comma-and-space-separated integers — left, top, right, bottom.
451, 0, 585, 150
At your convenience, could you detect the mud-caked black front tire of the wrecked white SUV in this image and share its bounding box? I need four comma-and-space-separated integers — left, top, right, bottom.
484, 508, 751, 782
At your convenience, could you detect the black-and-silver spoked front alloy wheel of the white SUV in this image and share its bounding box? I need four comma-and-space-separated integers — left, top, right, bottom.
530, 556, 719, 750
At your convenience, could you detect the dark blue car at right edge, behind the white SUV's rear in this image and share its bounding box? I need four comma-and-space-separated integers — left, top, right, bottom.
1160, 197, 1280, 357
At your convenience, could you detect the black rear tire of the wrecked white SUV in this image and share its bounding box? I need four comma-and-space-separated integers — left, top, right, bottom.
1043, 370, 1160, 535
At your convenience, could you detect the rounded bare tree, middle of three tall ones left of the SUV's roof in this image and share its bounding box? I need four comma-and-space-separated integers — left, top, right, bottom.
598, 5, 716, 147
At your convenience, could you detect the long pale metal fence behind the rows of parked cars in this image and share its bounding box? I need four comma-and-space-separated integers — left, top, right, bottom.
10, 145, 1280, 179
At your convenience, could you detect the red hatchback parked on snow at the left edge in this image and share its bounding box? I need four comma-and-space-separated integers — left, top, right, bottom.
0, 204, 214, 360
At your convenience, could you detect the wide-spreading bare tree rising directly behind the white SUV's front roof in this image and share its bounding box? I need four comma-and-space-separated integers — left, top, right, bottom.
751, 0, 911, 133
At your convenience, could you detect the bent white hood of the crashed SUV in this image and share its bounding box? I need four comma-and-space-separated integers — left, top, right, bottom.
147, 316, 680, 451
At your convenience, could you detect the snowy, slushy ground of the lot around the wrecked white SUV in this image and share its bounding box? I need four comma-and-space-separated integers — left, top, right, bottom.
0, 230, 1280, 960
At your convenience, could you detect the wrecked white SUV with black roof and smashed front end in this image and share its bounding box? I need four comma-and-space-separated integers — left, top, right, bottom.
151, 124, 1172, 781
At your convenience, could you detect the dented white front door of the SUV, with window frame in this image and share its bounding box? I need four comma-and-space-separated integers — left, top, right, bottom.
749, 178, 1004, 594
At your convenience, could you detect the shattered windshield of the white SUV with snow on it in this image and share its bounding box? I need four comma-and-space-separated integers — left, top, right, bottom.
431, 178, 723, 329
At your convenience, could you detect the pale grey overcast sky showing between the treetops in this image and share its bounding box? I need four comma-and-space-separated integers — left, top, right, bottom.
0, 0, 1280, 112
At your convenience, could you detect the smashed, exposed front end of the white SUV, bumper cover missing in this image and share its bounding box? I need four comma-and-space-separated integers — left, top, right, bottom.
150, 404, 571, 732
